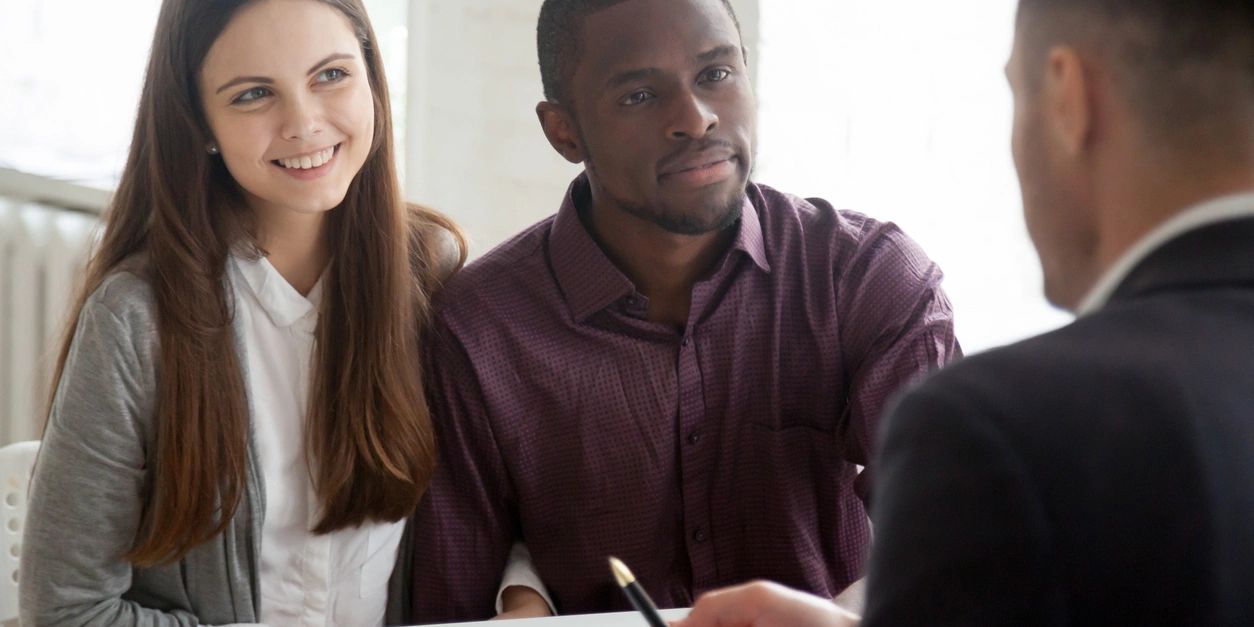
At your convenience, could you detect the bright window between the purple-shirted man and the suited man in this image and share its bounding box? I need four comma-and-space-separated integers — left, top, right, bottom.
755, 0, 1068, 352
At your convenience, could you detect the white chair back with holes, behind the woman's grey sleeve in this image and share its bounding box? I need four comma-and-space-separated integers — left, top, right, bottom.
0, 440, 39, 622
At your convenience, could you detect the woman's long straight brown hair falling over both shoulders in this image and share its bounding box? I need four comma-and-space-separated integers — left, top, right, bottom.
44, 0, 465, 566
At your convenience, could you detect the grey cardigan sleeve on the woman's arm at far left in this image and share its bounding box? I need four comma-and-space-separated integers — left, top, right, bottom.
20, 295, 197, 627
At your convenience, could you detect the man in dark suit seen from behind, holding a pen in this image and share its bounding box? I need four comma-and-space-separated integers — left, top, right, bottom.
682, 0, 1254, 627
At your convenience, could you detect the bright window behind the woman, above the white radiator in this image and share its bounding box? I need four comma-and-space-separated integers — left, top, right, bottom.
0, 0, 159, 187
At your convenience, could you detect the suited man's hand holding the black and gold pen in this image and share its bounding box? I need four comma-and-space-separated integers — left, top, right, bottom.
673, 582, 859, 627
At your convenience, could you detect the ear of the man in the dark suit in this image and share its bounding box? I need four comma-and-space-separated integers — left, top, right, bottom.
1043, 46, 1096, 157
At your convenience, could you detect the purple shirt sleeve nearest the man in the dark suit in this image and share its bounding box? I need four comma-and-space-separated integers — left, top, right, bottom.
838, 223, 962, 505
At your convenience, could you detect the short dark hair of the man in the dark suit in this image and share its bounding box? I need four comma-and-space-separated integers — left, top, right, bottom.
1017, 0, 1254, 148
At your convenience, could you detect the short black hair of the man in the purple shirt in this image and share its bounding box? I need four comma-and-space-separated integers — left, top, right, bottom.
535, 0, 740, 103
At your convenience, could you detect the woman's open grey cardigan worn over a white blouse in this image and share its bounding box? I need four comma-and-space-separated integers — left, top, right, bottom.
19, 263, 409, 626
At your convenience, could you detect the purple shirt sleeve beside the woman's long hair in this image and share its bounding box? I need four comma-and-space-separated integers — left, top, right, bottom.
411, 319, 518, 622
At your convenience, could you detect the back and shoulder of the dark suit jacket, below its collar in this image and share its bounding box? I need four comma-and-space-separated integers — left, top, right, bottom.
868, 282, 1254, 624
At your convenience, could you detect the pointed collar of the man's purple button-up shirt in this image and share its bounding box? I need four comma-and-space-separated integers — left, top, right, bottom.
548, 173, 771, 322
